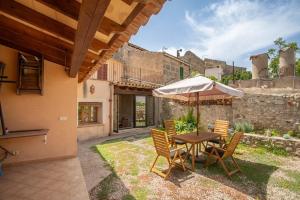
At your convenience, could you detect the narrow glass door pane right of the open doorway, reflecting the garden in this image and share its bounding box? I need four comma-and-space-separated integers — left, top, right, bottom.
135, 96, 146, 127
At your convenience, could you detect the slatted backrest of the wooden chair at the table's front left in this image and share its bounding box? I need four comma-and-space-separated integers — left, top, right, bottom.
151, 129, 170, 158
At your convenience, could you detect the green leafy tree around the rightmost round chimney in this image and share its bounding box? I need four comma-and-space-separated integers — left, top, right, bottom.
268, 37, 300, 78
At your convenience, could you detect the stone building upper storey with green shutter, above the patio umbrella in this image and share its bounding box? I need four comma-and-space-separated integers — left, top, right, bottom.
113, 43, 192, 85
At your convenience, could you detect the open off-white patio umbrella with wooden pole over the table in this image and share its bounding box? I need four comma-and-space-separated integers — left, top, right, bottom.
153, 75, 244, 135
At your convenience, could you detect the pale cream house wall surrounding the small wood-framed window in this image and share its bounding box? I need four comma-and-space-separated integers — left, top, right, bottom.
77, 80, 113, 140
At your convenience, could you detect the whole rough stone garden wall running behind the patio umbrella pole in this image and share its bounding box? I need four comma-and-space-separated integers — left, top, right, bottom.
160, 92, 300, 131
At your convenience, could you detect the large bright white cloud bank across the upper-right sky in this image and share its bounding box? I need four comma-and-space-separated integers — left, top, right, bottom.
185, 0, 300, 63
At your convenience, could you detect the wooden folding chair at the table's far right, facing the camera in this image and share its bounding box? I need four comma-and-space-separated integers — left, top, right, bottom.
209, 120, 229, 147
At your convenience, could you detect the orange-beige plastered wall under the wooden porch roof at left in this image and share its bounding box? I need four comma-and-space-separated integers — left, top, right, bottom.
0, 45, 77, 163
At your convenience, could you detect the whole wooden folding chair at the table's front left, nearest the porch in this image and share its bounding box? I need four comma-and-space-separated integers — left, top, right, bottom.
150, 129, 185, 180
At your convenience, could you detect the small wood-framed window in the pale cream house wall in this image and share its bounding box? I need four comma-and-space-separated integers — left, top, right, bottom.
78, 102, 102, 125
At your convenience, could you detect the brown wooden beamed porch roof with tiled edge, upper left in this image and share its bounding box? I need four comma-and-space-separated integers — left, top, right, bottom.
0, 0, 165, 82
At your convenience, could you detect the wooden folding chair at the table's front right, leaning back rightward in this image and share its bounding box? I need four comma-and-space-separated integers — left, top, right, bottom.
205, 132, 243, 177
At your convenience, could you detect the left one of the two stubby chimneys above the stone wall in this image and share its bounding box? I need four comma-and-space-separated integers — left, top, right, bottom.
250, 53, 269, 79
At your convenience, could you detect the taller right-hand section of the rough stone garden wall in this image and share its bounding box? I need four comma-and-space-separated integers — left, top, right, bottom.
232, 93, 300, 131
